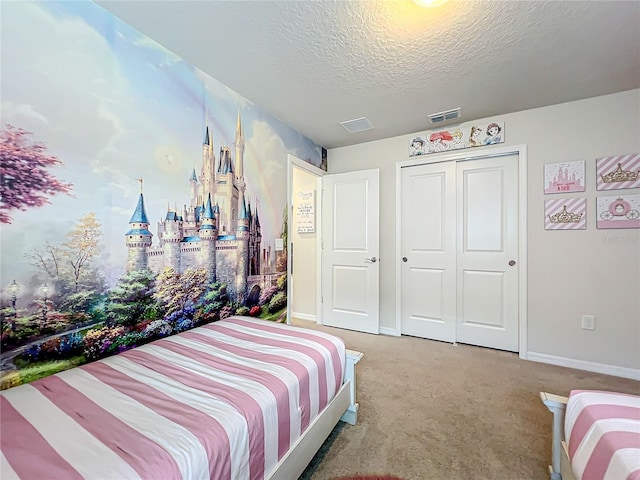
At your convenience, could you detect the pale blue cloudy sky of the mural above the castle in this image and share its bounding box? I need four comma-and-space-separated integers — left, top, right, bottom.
0, 2, 321, 287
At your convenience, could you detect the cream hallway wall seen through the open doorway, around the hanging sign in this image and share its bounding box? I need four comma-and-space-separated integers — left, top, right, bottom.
289, 166, 318, 320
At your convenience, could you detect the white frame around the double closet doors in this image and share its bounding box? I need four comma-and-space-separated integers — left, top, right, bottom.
394, 144, 527, 360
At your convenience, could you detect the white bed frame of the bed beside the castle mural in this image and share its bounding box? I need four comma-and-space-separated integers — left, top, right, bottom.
267, 350, 364, 480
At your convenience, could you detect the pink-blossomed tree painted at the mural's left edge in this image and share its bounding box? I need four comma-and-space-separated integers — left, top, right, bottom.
0, 124, 73, 223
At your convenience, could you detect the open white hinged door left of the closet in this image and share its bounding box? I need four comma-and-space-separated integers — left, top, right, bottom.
321, 169, 380, 333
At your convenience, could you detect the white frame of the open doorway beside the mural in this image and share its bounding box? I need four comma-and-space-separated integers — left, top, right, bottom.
287, 154, 327, 325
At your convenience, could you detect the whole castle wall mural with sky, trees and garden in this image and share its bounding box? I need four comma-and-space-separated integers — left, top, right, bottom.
0, 1, 326, 388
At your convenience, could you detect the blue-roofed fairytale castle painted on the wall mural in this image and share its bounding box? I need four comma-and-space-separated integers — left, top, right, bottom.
126, 112, 282, 304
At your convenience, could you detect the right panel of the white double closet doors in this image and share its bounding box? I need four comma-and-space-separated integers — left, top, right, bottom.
456, 155, 518, 352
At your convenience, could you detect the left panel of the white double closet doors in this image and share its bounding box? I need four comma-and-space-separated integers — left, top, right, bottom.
401, 162, 456, 342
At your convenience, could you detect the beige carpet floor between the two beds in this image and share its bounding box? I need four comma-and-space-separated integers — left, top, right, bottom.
293, 320, 640, 480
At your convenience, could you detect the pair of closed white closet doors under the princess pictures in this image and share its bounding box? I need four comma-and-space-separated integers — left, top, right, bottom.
400, 154, 519, 351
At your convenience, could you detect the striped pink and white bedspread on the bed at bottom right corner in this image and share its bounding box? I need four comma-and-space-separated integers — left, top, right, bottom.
565, 390, 640, 480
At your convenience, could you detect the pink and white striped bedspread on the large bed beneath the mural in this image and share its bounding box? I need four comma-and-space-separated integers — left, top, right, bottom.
0, 317, 345, 480
